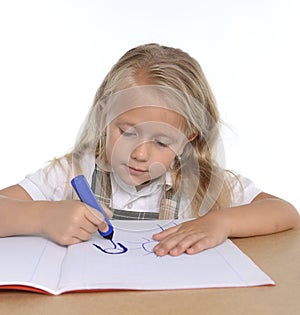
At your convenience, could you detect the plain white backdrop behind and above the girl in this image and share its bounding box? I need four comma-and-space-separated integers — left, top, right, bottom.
0, 0, 300, 210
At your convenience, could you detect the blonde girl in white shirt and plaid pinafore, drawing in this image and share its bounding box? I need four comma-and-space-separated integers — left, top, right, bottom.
0, 44, 299, 256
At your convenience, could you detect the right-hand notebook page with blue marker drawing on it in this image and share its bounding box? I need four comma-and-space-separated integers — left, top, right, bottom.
59, 221, 274, 292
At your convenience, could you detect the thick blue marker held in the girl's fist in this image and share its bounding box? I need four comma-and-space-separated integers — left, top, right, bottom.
71, 175, 114, 240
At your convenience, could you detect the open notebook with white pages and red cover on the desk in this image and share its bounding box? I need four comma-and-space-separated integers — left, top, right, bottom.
0, 220, 274, 295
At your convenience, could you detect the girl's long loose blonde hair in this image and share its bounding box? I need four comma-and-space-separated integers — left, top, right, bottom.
62, 44, 231, 216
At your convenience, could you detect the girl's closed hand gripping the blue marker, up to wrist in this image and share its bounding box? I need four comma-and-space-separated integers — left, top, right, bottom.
40, 200, 111, 245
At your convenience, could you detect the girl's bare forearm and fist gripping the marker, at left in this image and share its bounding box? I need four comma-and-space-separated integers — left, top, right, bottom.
0, 185, 107, 245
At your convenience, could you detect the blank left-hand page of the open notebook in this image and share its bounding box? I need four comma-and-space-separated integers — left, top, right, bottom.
0, 236, 66, 293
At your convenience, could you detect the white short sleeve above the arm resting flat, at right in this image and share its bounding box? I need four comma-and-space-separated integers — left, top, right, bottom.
228, 174, 262, 207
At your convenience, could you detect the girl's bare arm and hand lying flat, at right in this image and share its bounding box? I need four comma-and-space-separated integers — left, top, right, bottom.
153, 193, 300, 256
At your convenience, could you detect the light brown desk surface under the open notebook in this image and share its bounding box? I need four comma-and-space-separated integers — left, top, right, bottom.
0, 226, 300, 315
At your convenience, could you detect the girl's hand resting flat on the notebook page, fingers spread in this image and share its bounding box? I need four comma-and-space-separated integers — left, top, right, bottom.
153, 210, 230, 256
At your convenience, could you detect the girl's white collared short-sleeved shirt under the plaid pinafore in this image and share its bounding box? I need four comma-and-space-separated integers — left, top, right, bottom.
19, 155, 261, 218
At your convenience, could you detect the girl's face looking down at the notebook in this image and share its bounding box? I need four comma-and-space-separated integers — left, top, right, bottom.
106, 106, 187, 186
